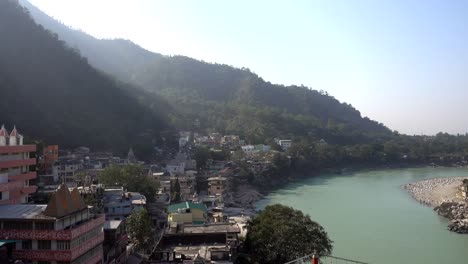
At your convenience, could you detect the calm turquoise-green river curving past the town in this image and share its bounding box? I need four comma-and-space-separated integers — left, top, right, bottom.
257, 168, 468, 264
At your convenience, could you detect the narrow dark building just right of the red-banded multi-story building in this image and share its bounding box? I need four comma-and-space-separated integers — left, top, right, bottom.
103, 220, 128, 264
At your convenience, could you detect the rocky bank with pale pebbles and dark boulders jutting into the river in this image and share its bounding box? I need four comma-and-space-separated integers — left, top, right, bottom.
403, 177, 468, 234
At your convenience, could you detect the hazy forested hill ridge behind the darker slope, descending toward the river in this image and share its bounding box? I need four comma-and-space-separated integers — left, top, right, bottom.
21, 0, 391, 144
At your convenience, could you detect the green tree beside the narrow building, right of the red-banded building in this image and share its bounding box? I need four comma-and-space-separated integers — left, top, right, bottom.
127, 208, 154, 250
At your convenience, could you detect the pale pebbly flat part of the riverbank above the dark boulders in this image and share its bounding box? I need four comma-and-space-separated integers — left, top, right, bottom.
402, 177, 468, 207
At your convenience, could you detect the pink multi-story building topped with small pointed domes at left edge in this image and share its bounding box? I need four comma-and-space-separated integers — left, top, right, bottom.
0, 125, 37, 205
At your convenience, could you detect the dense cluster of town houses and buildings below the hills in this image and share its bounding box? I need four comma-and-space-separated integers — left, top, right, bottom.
0, 127, 291, 263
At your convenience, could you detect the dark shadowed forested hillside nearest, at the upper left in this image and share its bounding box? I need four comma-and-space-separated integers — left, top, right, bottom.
0, 1, 171, 151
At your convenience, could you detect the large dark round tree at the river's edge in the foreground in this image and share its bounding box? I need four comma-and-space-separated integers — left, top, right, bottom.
245, 204, 333, 263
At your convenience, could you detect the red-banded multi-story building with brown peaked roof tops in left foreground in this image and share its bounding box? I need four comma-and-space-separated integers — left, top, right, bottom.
0, 184, 105, 264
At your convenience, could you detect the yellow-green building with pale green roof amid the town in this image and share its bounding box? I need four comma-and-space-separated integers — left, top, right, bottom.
167, 202, 208, 224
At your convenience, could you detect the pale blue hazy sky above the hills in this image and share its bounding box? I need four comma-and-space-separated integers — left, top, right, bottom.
30, 0, 468, 135
